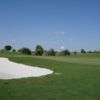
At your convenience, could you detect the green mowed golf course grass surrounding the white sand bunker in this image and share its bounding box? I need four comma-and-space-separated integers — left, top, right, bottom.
0, 54, 100, 100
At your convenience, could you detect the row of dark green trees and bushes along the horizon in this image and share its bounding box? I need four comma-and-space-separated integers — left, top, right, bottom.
0, 45, 100, 56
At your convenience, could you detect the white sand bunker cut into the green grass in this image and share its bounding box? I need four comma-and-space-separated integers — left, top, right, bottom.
0, 57, 53, 79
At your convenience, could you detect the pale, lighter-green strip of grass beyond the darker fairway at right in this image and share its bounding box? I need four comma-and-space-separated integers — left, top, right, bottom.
34, 55, 100, 65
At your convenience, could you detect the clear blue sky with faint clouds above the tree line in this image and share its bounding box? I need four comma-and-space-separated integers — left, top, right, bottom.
0, 0, 100, 51
